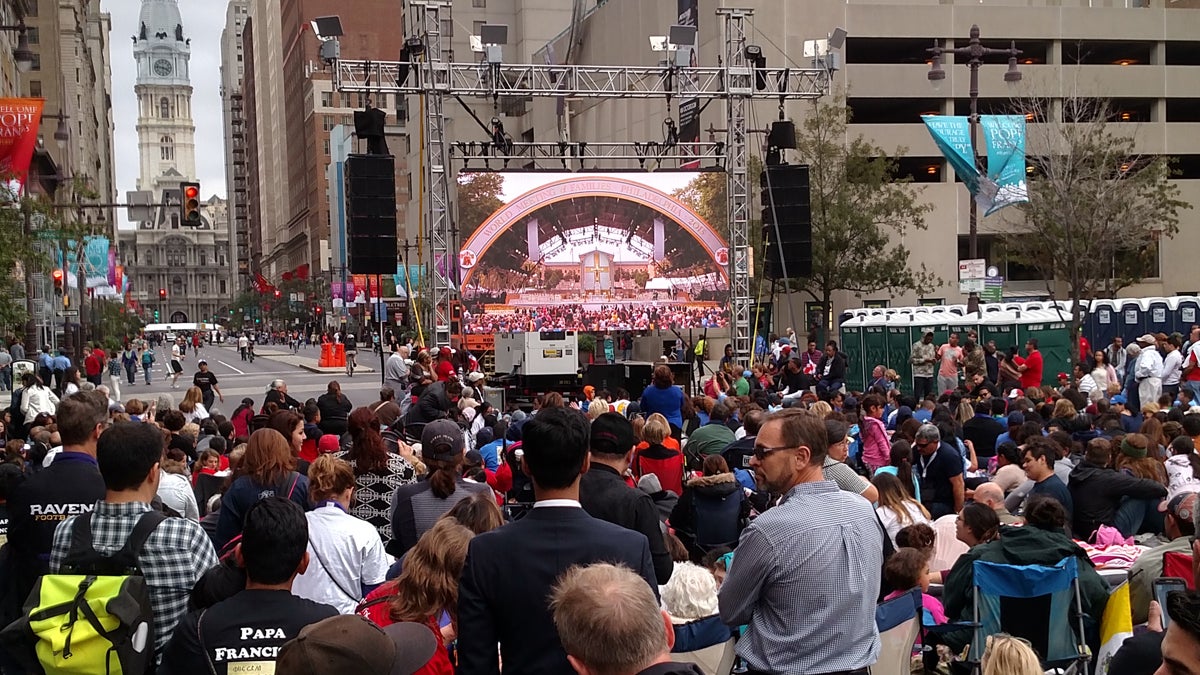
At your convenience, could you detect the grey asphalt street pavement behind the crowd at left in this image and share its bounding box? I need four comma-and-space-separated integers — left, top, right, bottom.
0, 345, 393, 416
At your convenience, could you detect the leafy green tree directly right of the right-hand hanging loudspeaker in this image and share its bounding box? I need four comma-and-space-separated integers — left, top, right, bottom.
793, 98, 941, 333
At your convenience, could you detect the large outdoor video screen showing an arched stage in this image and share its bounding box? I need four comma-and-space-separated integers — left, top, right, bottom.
458, 173, 730, 333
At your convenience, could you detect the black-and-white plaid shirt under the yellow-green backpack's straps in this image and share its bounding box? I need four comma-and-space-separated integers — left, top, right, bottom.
50, 501, 217, 652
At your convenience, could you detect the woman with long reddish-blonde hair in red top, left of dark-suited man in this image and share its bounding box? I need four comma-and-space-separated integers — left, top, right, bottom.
358, 518, 475, 675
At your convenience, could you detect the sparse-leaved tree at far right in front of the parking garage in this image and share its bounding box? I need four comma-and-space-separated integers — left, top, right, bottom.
1003, 95, 1192, 357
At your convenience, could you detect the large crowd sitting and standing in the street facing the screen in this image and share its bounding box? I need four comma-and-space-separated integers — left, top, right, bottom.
0, 324, 1200, 675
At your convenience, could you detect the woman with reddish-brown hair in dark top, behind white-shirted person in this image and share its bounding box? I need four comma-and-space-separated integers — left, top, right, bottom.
212, 429, 312, 550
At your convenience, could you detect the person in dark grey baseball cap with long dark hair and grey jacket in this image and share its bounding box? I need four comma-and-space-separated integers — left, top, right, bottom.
388, 419, 492, 557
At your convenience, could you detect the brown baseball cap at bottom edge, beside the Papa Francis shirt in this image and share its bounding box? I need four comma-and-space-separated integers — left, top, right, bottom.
276, 614, 438, 675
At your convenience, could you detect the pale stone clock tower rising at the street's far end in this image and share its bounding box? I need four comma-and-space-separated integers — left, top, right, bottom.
133, 0, 196, 193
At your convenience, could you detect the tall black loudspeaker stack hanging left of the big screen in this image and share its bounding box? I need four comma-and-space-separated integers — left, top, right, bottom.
346, 155, 396, 274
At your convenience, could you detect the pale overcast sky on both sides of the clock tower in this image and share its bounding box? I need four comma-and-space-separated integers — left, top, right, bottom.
101, 0, 228, 227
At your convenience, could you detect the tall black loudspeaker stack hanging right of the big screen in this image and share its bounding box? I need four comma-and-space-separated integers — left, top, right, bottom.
760, 165, 812, 279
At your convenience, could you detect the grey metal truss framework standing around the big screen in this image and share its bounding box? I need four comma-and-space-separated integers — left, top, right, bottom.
332, 0, 832, 359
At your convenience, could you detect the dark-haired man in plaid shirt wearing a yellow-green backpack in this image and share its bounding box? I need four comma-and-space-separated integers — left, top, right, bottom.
50, 422, 217, 652
